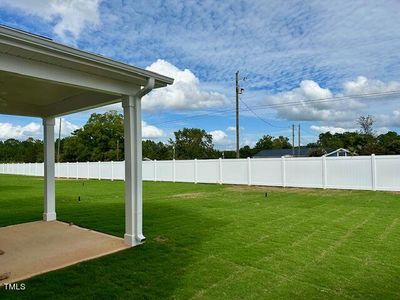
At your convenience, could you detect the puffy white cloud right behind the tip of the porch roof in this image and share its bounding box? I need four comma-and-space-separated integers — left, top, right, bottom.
142, 59, 226, 111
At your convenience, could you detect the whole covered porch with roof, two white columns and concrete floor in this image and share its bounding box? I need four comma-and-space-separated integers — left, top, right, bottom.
0, 26, 173, 283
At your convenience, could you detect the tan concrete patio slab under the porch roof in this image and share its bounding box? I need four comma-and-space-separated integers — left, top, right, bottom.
0, 221, 129, 286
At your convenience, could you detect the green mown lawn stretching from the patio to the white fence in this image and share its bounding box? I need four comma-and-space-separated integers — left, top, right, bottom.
0, 175, 400, 299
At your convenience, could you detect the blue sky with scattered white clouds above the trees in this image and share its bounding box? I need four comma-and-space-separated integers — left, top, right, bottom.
0, 0, 400, 149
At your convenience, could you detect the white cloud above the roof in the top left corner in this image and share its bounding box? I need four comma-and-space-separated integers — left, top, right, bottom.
0, 0, 100, 43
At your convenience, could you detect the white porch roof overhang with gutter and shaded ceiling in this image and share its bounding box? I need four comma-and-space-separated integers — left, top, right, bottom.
0, 26, 173, 117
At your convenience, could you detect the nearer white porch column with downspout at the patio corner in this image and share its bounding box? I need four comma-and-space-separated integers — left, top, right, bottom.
122, 96, 145, 246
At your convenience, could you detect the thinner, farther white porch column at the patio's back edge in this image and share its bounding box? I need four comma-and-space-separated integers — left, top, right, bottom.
43, 117, 56, 221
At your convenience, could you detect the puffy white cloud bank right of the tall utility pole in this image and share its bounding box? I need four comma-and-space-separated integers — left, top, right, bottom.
267, 76, 400, 128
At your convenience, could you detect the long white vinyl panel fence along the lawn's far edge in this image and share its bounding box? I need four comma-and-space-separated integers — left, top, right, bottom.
0, 155, 400, 191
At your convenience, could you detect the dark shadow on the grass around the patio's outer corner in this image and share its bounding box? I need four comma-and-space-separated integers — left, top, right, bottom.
0, 202, 223, 299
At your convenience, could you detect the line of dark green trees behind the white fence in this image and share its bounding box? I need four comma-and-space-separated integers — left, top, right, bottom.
0, 111, 400, 162
